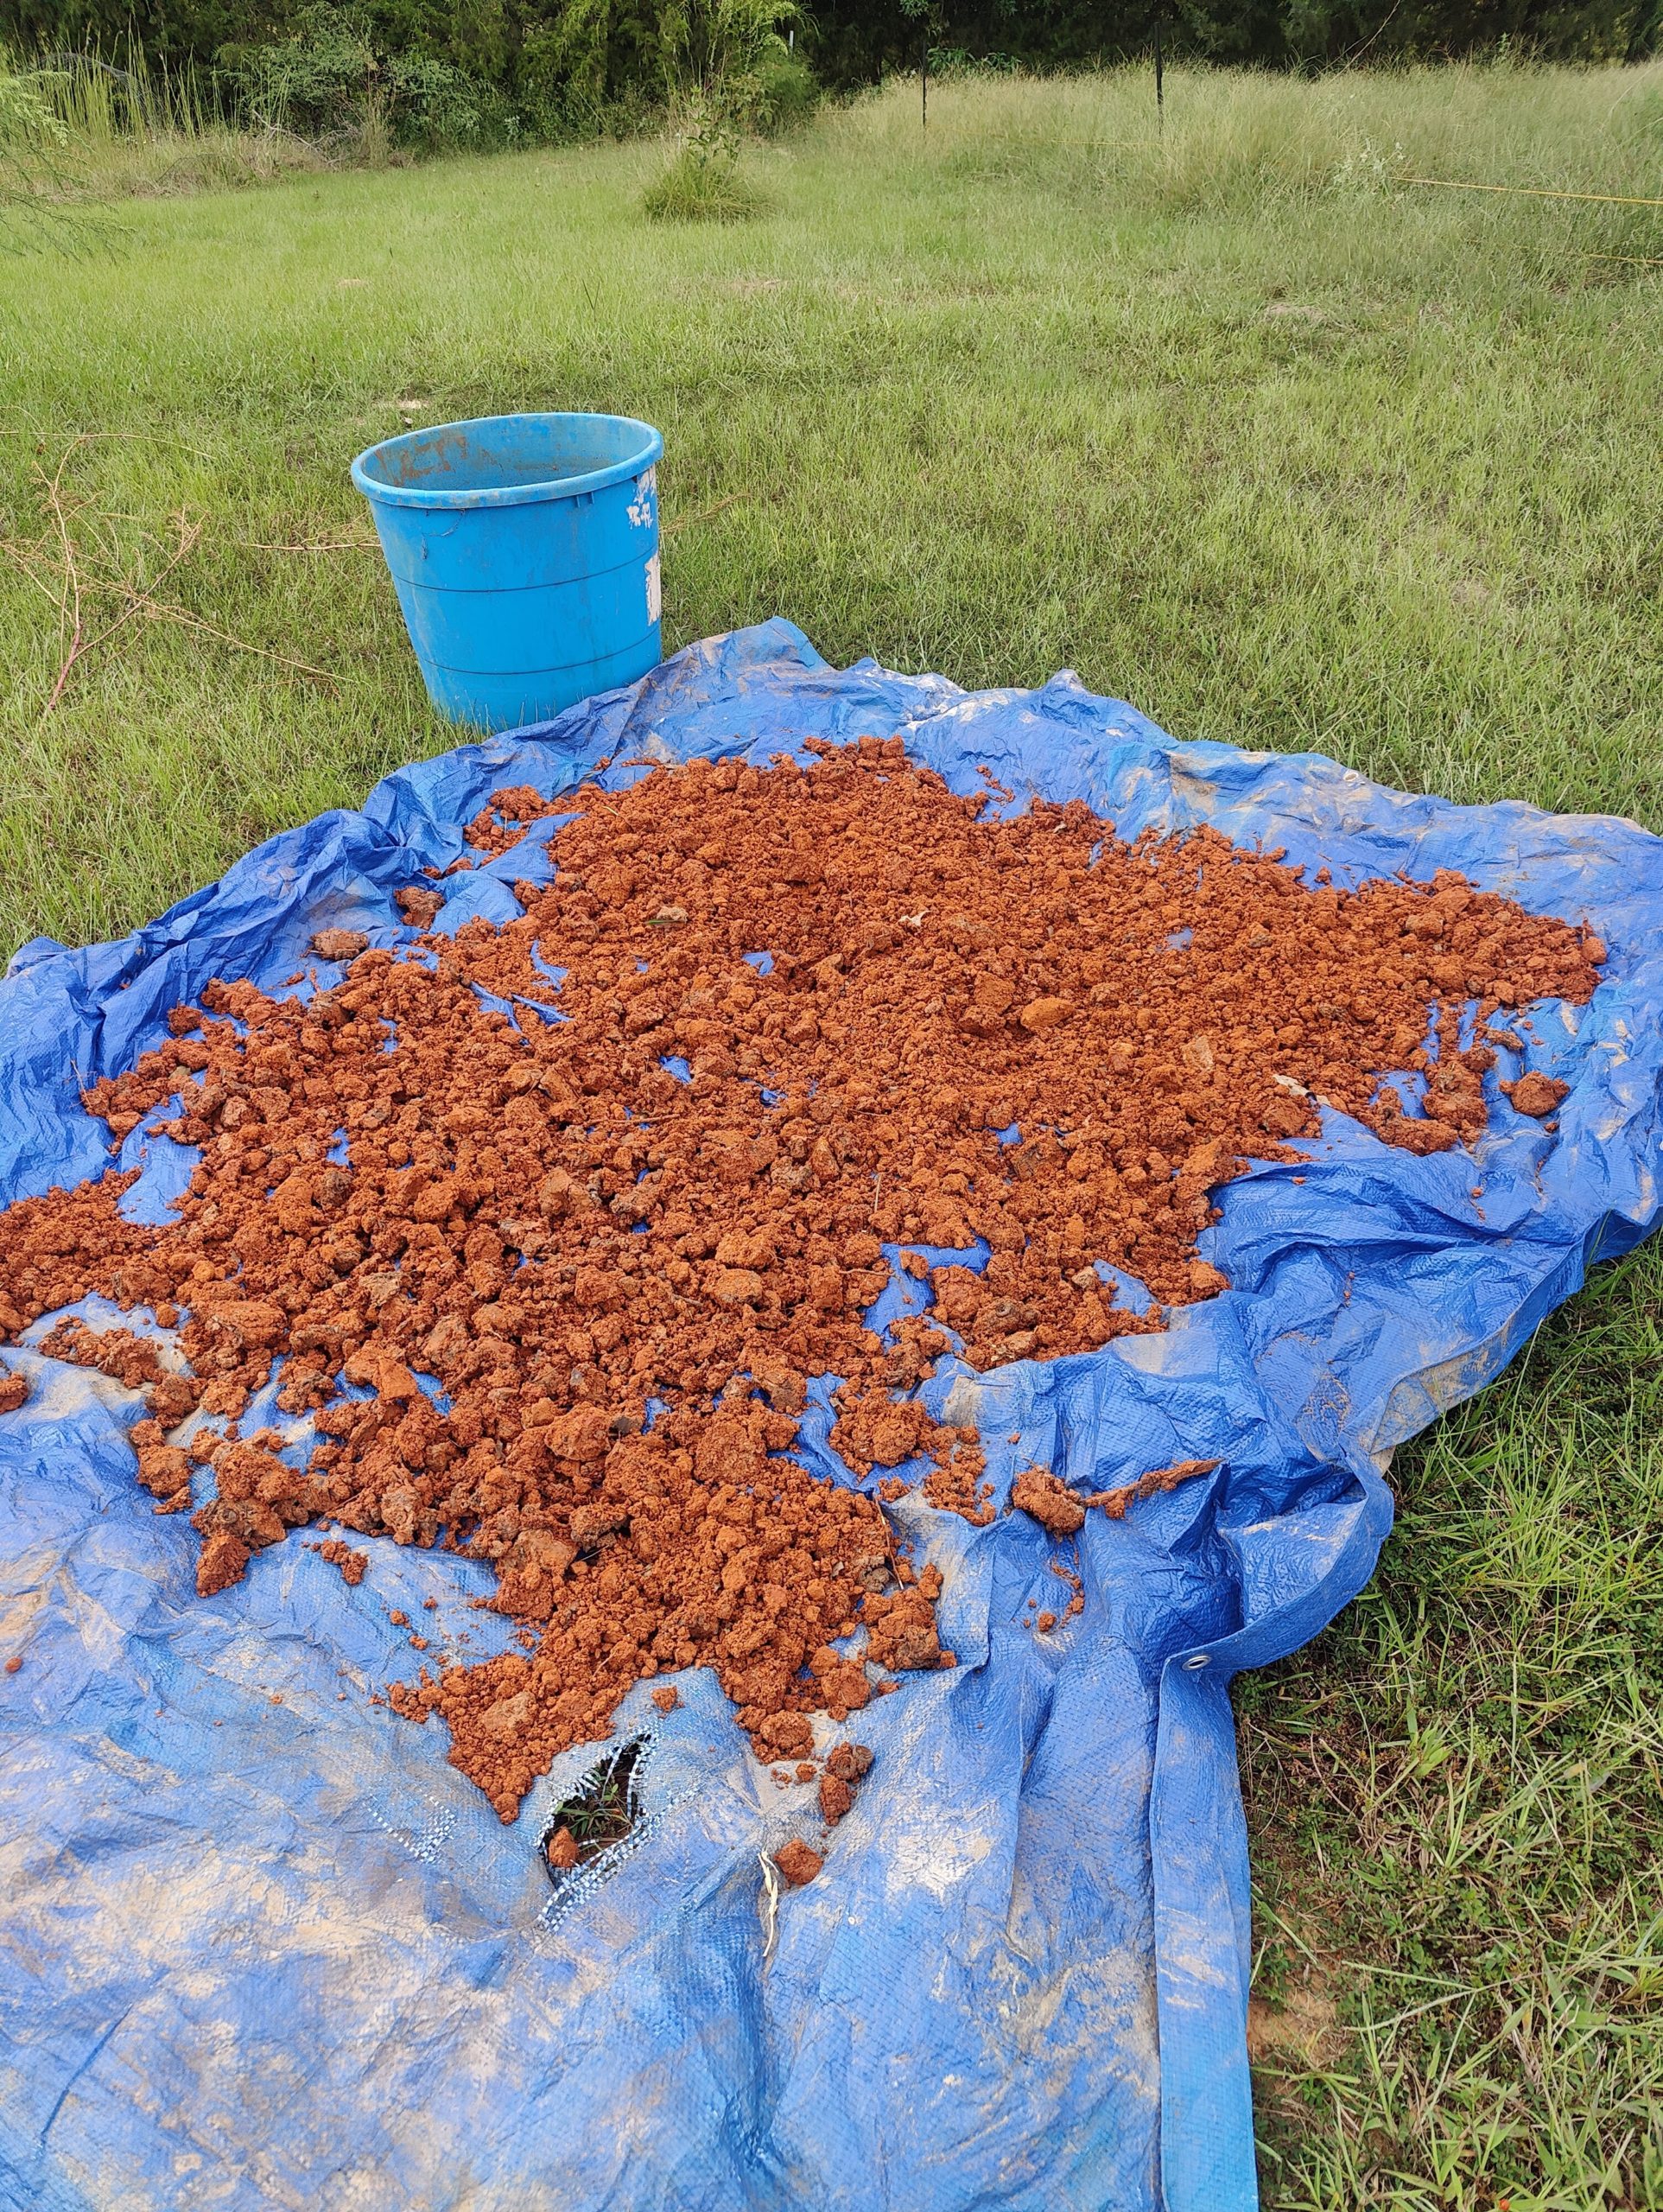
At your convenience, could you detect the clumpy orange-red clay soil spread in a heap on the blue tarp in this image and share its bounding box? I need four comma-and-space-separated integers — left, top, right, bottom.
0, 739, 1603, 1818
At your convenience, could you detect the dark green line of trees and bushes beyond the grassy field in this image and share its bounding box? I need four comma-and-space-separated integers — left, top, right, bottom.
0, 0, 1663, 142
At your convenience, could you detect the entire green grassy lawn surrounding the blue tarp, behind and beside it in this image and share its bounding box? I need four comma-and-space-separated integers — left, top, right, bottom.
0, 67, 1663, 2212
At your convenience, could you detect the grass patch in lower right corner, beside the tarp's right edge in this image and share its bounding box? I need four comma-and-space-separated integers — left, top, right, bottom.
1236, 1245, 1663, 2212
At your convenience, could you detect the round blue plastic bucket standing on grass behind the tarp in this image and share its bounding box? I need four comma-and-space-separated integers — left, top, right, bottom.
352, 414, 663, 730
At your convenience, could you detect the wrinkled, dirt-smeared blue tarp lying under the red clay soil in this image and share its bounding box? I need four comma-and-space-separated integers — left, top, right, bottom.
0, 621, 1663, 2212
